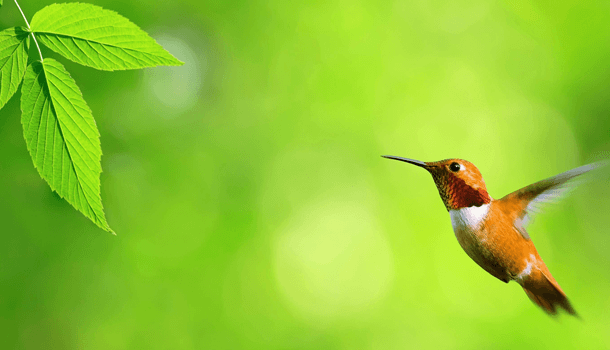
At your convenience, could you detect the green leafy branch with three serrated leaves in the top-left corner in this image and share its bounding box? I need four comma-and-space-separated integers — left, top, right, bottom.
0, 0, 183, 233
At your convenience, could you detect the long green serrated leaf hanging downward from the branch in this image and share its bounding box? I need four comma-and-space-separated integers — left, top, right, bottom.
21, 58, 112, 232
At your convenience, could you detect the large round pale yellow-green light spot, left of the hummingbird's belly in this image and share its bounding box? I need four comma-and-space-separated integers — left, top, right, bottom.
275, 200, 393, 324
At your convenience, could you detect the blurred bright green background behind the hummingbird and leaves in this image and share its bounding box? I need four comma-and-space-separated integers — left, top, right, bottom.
0, 0, 610, 349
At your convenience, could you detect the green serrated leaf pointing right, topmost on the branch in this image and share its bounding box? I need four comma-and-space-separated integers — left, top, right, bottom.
30, 3, 183, 70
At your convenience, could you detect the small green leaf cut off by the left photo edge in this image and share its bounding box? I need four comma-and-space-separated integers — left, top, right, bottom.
0, 26, 30, 108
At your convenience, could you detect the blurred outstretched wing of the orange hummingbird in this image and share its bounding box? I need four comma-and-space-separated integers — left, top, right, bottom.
500, 161, 609, 238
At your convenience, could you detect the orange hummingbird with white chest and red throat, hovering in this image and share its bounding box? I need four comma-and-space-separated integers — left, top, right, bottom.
382, 156, 602, 316
